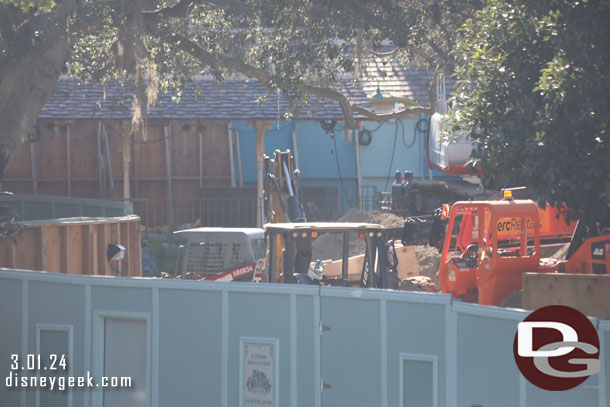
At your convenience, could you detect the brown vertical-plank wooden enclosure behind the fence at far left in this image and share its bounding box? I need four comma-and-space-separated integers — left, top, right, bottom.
0, 215, 142, 277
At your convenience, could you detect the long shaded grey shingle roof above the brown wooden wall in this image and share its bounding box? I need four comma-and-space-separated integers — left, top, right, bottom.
39, 79, 371, 120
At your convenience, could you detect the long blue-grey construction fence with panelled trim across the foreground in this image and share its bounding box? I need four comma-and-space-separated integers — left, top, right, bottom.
0, 270, 610, 407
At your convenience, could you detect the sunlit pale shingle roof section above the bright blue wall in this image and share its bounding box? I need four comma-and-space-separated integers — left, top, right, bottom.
361, 56, 455, 107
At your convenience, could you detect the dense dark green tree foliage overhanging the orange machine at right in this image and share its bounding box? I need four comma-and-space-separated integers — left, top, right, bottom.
454, 0, 610, 221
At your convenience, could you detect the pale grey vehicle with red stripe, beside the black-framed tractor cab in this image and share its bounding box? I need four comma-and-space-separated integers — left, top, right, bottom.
174, 228, 266, 281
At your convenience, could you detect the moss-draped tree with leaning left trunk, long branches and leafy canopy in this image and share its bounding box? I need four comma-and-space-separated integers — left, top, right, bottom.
0, 0, 480, 173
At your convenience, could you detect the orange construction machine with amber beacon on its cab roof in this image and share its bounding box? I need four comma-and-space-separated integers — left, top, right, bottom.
405, 188, 610, 305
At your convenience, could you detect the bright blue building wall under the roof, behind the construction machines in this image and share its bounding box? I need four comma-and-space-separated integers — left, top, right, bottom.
233, 115, 442, 215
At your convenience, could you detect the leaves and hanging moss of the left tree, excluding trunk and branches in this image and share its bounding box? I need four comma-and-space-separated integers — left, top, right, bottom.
0, 0, 482, 121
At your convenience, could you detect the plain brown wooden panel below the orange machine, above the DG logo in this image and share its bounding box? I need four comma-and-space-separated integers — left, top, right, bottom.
523, 273, 610, 319
